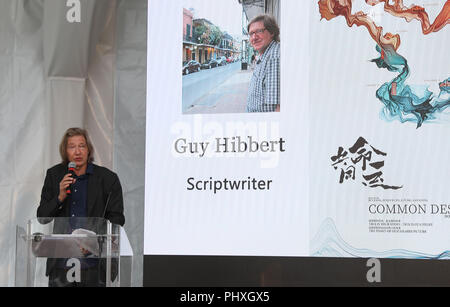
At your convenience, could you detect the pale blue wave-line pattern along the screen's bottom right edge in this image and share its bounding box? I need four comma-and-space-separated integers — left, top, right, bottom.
311, 218, 450, 260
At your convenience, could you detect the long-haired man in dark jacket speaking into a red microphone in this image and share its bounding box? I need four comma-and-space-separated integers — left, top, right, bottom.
37, 128, 125, 286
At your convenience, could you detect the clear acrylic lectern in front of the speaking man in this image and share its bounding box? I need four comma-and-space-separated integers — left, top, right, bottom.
15, 217, 131, 287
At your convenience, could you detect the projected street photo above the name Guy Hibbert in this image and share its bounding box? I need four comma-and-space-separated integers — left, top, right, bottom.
181, 0, 280, 114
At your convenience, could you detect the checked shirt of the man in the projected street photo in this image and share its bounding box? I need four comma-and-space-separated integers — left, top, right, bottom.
247, 41, 280, 113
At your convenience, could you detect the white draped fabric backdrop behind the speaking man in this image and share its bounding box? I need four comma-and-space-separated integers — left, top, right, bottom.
0, 0, 147, 286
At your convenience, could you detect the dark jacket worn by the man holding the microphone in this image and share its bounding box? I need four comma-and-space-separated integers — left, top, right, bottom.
37, 164, 125, 275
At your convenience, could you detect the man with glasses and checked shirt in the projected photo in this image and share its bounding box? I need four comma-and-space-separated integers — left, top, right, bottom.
247, 15, 280, 113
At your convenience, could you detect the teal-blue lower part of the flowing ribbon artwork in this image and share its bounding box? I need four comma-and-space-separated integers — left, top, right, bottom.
372, 46, 450, 128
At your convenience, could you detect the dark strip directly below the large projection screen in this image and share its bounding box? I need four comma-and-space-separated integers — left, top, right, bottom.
144, 256, 450, 287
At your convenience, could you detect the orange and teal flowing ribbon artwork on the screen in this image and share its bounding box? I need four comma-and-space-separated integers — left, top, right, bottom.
318, 0, 450, 128
